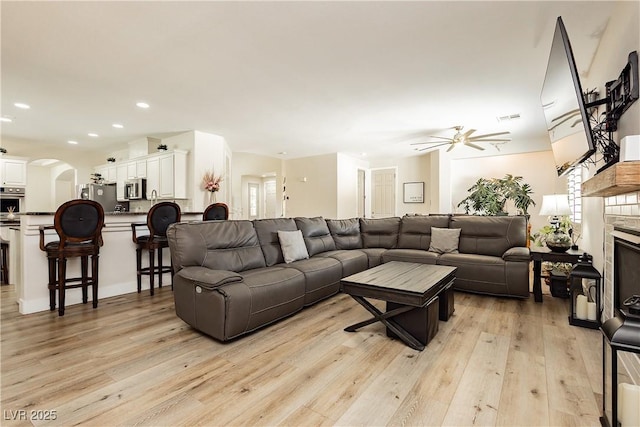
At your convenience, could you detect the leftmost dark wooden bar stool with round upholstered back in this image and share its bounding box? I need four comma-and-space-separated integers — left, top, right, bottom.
40, 199, 104, 316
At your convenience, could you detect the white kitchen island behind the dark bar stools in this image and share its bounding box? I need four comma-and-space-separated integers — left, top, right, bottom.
9, 212, 202, 314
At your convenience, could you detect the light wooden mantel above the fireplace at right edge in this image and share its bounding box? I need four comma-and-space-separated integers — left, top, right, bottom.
582, 161, 640, 197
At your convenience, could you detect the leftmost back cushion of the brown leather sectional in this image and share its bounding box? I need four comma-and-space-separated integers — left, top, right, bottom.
167, 220, 266, 272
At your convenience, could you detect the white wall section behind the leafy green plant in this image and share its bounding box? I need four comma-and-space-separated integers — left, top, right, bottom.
451, 151, 567, 237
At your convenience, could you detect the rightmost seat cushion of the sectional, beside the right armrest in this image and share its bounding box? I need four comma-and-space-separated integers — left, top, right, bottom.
438, 254, 507, 295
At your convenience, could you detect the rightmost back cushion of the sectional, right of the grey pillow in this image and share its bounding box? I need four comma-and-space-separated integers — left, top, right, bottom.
450, 215, 527, 256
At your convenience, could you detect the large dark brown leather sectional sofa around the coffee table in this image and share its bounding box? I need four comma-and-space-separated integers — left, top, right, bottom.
167, 215, 529, 341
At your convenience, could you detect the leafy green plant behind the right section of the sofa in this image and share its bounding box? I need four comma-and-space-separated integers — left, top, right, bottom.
458, 174, 536, 215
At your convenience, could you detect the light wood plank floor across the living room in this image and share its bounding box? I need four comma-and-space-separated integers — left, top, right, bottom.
0, 285, 602, 426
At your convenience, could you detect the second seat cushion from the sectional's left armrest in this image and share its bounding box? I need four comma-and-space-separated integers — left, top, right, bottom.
278, 256, 342, 305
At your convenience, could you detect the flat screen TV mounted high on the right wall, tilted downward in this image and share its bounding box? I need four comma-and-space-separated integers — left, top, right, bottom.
540, 17, 596, 176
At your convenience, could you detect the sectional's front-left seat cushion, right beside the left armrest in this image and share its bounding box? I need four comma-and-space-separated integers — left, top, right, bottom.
241, 267, 305, 333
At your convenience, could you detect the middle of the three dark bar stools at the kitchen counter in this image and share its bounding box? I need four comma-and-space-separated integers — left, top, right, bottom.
131, 202, 180, 295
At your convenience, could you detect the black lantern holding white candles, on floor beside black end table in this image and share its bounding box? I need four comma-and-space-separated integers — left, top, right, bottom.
569, 252, 602, 329
